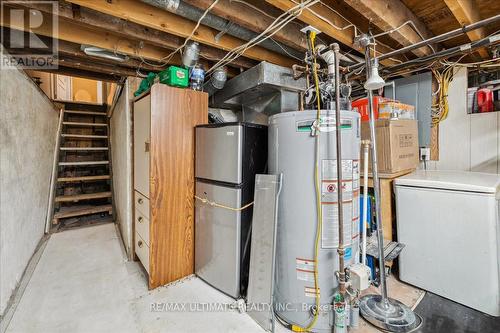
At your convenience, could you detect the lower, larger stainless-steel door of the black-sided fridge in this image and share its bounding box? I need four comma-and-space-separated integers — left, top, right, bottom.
195, 181, 241, 298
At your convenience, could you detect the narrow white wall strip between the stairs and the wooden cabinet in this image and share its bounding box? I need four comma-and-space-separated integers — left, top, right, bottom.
110, 80, 133, 259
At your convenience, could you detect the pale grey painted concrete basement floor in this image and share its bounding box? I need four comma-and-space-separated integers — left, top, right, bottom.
7, 224, 422, 333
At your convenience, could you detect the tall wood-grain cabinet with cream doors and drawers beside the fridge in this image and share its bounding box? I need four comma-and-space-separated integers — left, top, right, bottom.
133, 84, 208, 289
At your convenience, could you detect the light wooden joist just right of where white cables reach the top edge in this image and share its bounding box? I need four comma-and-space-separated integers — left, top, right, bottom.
266, 0, 398, 65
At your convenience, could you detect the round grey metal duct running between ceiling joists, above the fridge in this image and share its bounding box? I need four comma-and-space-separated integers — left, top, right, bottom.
141, 0, 304, 59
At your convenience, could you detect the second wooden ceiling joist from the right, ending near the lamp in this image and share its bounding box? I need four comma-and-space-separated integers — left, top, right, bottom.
344, 0, 433, 57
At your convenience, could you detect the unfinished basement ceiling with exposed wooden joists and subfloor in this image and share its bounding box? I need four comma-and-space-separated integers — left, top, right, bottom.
2, 0, 500, 81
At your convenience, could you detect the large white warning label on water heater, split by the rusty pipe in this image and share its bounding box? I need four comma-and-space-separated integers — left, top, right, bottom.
321, 160, 359, 249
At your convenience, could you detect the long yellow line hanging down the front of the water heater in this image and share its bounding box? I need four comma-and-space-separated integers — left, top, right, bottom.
291, 31, 323, 332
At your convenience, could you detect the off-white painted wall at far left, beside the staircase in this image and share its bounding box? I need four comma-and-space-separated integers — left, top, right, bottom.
0, 62, 59, 315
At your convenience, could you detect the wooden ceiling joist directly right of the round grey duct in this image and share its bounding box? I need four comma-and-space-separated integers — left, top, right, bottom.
183, 0, 307, 51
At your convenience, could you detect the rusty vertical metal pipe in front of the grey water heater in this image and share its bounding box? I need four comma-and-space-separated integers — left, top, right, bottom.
332, 43, 346, 295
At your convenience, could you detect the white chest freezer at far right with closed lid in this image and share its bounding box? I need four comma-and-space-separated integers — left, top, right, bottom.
395, 171, 500, 316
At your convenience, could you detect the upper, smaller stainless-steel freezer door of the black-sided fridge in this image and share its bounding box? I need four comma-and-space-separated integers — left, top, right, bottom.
195, 125, 243, 184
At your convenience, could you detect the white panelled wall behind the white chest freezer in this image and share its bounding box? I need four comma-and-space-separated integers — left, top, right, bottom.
427, 68, 500, 173
